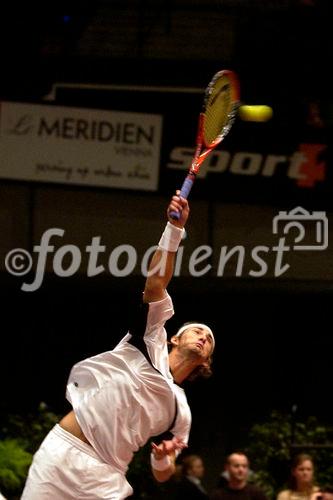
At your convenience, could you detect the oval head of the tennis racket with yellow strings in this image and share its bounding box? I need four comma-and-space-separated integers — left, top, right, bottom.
201, 70, 240, 148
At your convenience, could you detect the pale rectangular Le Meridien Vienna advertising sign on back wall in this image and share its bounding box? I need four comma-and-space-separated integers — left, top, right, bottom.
0, 102, 162, 191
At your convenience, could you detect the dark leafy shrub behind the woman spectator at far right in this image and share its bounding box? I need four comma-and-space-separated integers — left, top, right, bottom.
245, 411, 333, 498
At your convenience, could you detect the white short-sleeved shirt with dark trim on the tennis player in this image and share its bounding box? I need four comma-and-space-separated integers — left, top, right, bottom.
67, 294, 191, 474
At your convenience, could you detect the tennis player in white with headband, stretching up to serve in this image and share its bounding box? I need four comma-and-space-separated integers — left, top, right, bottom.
21, 191, 215, 500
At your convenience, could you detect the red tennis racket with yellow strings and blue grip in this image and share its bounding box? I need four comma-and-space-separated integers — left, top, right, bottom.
170, 70, 240, 220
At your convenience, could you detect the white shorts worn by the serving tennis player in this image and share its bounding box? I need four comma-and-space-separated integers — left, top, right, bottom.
21, 424, 133, 500
